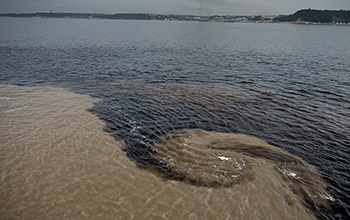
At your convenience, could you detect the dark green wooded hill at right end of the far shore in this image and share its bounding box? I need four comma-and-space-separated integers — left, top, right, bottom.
275, 9, 350, 23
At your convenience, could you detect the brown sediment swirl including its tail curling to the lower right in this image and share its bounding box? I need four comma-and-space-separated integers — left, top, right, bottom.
152, 129, 333, 217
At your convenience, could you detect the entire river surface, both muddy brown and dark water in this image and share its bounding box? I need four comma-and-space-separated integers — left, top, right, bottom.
0, 18, 350, 219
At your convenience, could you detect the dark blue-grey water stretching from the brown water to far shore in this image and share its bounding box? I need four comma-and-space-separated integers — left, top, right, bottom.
0, 18, 350, 219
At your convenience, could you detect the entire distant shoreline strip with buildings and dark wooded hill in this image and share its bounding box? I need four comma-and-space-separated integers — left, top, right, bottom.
0, 9, 350, 25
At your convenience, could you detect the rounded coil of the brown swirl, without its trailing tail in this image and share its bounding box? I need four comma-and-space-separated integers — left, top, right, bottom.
152, 130, 253, 187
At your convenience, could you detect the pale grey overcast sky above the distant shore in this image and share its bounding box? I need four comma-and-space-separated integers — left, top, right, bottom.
0, 0, 350, 15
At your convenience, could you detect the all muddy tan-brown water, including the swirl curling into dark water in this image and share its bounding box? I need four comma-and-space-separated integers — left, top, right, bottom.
0, 86, 332, 219
